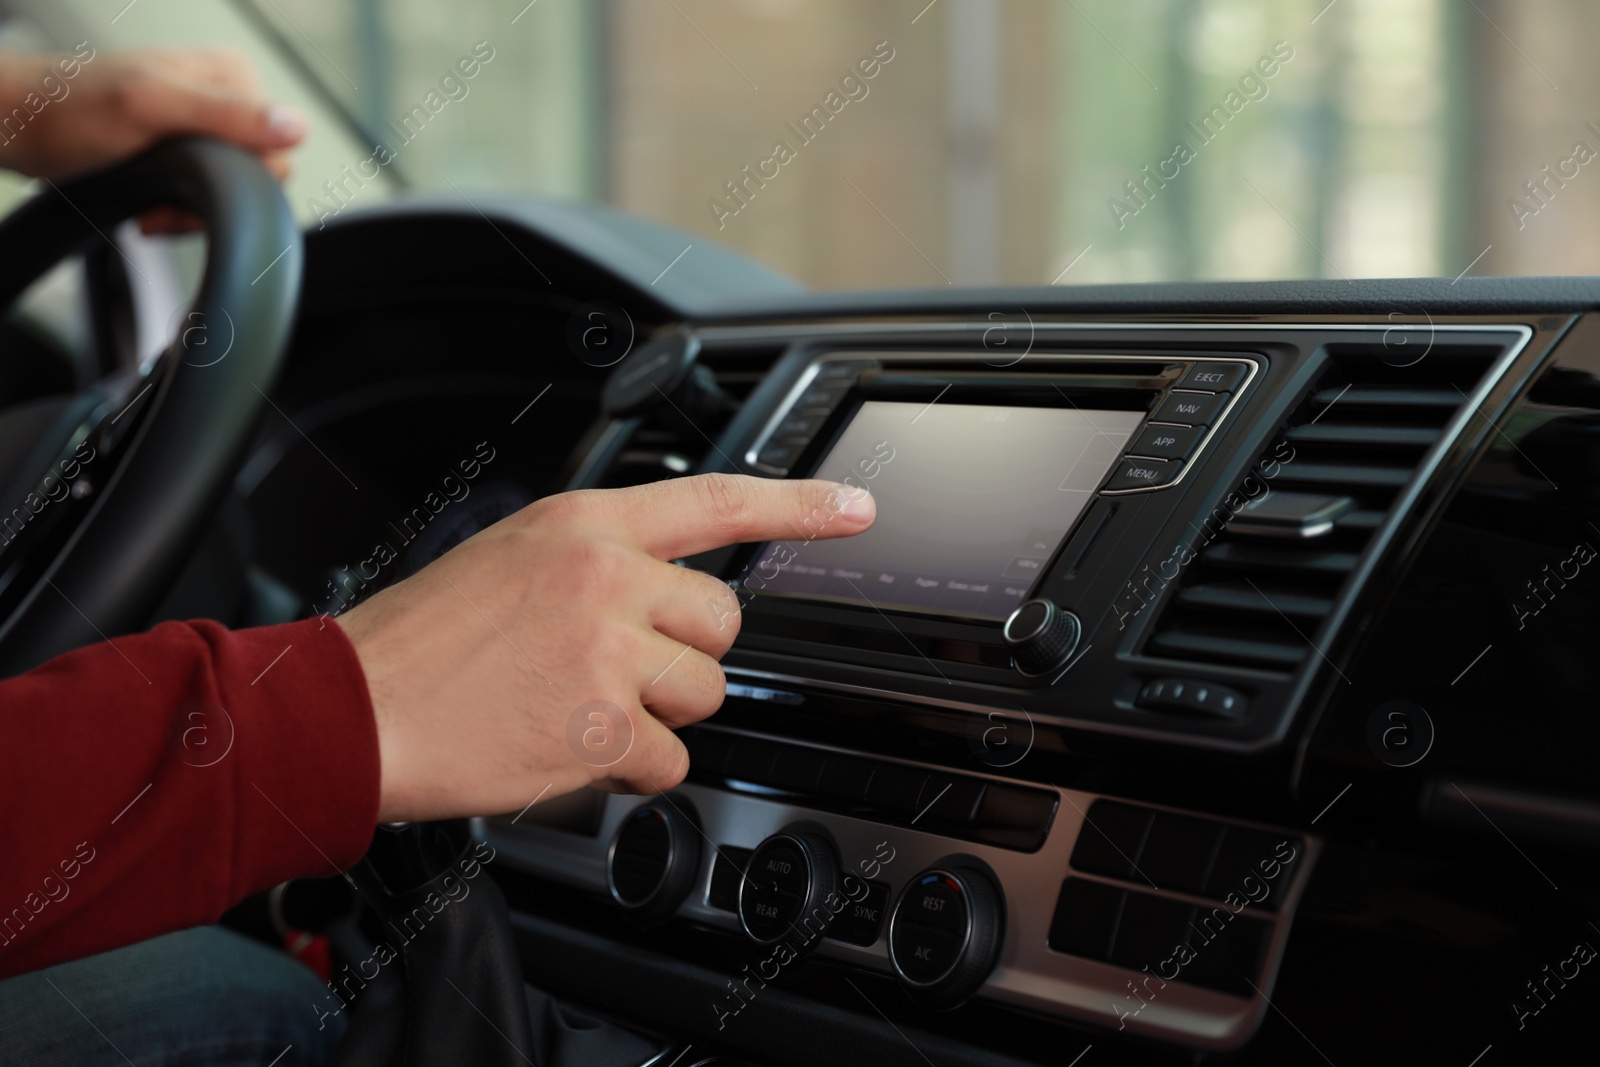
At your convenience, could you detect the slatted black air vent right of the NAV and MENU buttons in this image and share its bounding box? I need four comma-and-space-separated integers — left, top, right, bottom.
1146, 346, 1501, 672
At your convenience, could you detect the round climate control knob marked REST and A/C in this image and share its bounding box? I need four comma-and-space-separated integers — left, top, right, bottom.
890, 857, 1005, 1008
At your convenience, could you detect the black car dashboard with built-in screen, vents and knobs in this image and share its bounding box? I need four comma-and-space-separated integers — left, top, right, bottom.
222, 202, 1600, 1064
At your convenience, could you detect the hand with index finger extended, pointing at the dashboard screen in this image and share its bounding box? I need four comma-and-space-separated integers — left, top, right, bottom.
338, 475, 875, 822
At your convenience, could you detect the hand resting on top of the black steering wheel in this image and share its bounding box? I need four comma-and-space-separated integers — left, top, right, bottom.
0, 48, 306, 179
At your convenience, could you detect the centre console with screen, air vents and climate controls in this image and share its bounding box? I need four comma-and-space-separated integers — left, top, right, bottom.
478, 322, 1531, 1049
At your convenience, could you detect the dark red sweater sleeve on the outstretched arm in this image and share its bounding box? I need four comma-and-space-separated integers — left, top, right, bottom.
0, 619, 378, 977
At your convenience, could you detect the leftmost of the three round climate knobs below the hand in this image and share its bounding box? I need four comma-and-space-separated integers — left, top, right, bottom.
606, 798, 701, 926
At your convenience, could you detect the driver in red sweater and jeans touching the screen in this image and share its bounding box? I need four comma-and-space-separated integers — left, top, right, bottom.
0, 51, 875, 1067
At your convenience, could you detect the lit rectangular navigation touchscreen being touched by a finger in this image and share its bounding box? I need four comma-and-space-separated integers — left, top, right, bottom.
746, 400, 1144, 619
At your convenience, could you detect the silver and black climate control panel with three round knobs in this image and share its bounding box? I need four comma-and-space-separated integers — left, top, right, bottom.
478, 726, 1318, 1049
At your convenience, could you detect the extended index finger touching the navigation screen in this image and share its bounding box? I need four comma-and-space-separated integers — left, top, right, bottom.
602, 474, 877, 560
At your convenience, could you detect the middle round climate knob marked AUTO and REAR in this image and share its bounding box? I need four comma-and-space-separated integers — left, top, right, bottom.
739, 829, 838, 952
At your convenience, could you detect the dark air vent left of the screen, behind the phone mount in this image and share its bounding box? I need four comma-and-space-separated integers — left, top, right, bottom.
594, 346, 784, 490
